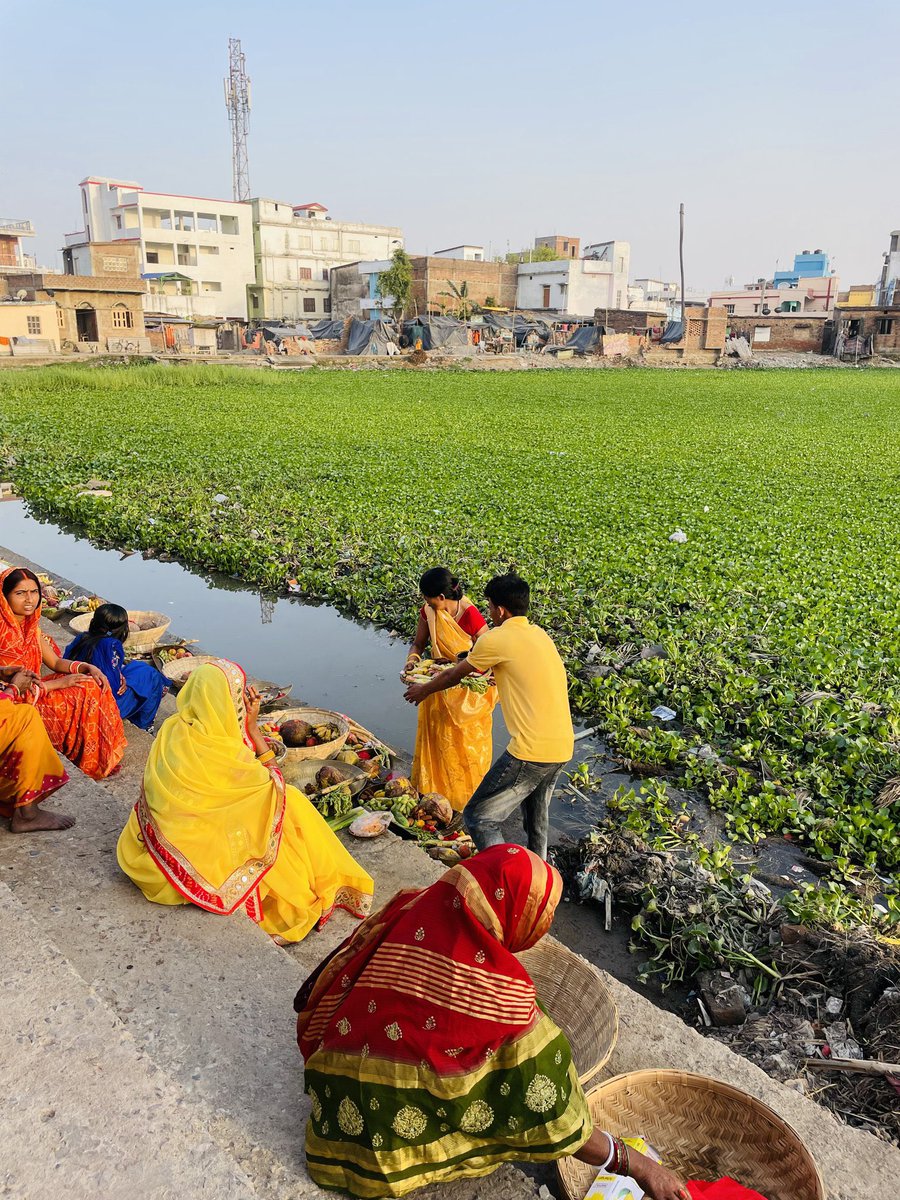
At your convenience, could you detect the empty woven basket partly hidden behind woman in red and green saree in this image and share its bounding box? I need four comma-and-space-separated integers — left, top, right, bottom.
516, 937, 619, 1084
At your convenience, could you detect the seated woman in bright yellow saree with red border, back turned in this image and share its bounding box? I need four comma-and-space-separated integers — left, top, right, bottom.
116, 659, 374, 942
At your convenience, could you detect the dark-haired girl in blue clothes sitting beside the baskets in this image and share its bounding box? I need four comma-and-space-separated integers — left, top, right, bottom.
62, 604, 169, 730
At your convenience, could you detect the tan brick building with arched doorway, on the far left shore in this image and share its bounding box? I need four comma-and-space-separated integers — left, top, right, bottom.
6, 241, 146, 350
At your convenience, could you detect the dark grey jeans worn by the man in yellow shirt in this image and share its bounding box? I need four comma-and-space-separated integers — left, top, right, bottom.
463, 750, 565, 858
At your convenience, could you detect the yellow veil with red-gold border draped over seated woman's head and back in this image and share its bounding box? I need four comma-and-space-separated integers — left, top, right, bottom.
137, 659, 284, 918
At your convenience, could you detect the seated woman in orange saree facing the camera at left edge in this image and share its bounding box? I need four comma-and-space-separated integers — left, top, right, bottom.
0, 566, 127, 779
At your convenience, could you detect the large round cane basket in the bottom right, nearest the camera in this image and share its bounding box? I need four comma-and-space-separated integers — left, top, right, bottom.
557, 1070, 826, 1200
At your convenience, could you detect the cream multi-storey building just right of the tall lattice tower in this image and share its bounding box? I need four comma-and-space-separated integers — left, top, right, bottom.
248, 198, 403, 322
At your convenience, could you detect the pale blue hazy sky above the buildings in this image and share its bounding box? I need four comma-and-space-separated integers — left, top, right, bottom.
0, 0, 900, 289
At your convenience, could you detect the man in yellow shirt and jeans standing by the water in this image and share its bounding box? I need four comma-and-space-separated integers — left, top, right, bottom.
406, 574, 575, 858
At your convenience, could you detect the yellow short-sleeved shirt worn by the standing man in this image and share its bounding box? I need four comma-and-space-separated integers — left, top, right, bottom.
469, 617, 575, 762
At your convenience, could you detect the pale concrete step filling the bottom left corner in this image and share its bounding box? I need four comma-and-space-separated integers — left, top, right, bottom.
0, 884, 264, 1200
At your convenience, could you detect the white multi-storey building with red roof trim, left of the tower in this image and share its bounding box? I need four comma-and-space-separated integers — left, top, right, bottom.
66, 175, 253, 318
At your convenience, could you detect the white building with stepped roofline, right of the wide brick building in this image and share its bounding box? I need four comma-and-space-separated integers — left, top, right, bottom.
516, 241, 631, 318
